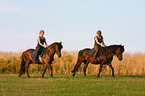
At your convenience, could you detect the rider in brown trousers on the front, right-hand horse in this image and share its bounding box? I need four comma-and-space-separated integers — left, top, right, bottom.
93, 30, 105, 61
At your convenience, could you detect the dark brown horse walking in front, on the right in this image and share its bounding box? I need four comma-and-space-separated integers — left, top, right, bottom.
71, 45, 125, 77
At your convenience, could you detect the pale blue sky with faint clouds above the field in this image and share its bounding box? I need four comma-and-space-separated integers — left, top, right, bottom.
0, 0, 145, 53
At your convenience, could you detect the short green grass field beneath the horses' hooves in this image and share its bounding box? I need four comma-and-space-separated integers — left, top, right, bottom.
0, 74, 145, 96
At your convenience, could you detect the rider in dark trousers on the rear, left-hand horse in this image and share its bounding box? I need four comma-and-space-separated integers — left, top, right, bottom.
34, 30, 48, 63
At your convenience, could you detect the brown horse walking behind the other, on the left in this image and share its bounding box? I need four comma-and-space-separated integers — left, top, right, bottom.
18, 42, 63, 78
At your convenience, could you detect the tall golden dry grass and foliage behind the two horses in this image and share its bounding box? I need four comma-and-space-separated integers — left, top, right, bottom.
0, 51, 145, 75
